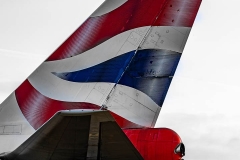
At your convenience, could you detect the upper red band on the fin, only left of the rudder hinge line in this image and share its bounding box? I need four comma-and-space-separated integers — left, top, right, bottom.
47, 0, 164, 61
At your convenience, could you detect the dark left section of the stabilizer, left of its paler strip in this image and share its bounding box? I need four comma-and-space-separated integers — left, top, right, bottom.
2, 113, 91, 160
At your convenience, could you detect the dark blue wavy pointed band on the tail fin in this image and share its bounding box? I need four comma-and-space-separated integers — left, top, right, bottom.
54, 49, 181, 106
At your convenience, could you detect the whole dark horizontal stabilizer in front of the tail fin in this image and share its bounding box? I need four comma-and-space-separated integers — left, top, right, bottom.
0, 110, 143, 160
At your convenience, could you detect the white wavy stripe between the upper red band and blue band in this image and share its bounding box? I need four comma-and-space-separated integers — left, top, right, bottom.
40, 26, 191, 72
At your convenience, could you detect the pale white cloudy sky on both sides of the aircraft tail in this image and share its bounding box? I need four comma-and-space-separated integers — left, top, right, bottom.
0, 0, 240, 160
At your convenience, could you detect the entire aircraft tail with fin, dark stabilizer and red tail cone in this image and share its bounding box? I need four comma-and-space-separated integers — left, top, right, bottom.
0, 0, 201, 160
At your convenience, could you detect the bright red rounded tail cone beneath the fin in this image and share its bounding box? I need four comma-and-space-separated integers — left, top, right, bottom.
123, 128, 185, 160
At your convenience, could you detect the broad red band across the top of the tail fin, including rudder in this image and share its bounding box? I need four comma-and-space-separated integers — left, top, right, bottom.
47, 0, 200, 61
